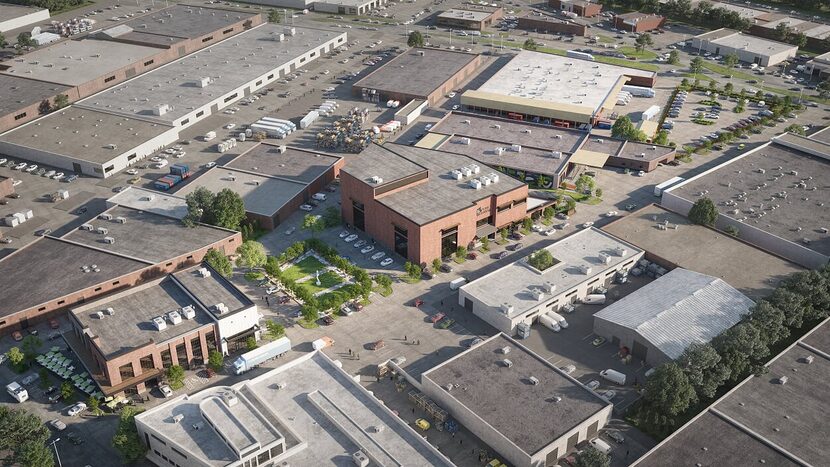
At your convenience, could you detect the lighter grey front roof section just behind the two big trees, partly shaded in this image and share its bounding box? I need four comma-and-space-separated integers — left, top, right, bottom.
176, 167, 306, 216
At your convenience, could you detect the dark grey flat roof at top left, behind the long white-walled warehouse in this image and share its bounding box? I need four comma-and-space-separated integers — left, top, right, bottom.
114, 5, 259, 39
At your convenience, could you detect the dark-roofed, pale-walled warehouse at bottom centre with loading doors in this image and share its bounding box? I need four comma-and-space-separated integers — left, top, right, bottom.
421, 333, 613, 467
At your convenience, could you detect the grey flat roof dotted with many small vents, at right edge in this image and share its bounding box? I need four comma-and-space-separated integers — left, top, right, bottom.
670, 143, 830, 256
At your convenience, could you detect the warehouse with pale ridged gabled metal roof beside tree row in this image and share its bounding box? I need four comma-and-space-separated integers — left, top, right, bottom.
594, 268, 755, 367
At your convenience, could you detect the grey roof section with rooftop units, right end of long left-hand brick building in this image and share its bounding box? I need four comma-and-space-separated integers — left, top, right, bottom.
62, 206, 234, 263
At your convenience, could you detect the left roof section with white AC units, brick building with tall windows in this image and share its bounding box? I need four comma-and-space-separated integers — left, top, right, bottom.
72, 276, 213, 358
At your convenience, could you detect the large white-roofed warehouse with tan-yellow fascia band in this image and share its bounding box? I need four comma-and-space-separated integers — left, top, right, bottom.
461, 50, 657, 127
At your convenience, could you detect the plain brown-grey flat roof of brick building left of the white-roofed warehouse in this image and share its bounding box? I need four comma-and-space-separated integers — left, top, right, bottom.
354, 48, 478, 98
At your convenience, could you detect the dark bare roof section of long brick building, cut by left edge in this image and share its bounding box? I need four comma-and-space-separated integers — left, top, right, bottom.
0, 237, 149, 316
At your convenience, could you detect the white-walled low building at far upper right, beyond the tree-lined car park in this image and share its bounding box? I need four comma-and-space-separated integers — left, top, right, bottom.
692, 29, 798, 67
